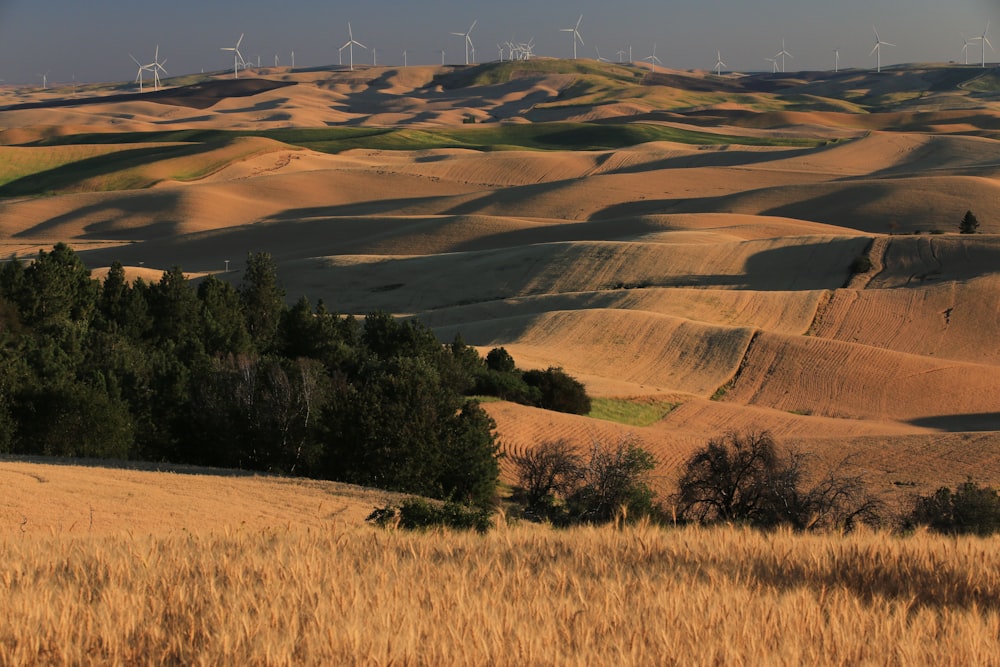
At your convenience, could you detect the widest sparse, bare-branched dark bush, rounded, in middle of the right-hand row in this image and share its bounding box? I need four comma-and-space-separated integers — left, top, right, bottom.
675, 431, 881, 530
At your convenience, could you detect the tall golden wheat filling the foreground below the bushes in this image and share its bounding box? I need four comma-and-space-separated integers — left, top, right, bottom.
0, 526, 1000, 665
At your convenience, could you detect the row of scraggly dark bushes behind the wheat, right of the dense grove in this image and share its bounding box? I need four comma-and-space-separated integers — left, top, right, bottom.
511, 431, 1000, 535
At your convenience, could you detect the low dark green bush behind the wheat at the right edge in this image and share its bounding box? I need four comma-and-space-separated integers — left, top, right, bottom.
904, 479, 1000, 535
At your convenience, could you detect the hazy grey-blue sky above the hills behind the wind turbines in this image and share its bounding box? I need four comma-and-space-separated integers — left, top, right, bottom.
0, 0, 1000, 86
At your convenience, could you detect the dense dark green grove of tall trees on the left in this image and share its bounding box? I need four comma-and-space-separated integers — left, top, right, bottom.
0, 244, 589, 506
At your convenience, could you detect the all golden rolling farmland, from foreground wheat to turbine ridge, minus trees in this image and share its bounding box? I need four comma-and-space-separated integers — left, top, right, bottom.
0, 60, 1000, 665
